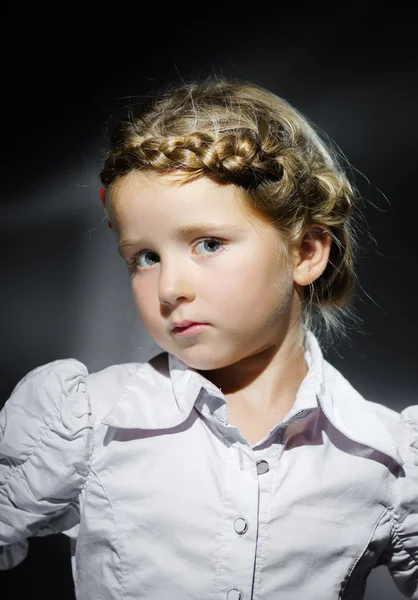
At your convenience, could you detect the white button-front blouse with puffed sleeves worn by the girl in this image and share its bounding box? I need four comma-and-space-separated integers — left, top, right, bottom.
0, 330, 418, 600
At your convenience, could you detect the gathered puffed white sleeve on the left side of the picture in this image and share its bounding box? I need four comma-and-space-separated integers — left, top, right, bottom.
0, 358, 93, 570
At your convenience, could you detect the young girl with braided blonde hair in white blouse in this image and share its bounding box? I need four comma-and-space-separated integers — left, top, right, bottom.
0, 79, 418, 600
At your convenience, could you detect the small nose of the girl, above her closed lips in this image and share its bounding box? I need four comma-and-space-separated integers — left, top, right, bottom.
158, 260, 195, 305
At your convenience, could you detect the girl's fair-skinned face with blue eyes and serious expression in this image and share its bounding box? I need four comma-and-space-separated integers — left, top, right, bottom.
111, 172, 297, 370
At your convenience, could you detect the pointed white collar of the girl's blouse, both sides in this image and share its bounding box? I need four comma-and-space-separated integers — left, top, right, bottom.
101, 329, 403, 465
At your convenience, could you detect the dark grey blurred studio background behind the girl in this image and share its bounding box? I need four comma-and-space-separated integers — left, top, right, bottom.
0, 3, 418, 600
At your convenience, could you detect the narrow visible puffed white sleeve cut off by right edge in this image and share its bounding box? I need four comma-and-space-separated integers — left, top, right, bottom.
385, 405, 418, 600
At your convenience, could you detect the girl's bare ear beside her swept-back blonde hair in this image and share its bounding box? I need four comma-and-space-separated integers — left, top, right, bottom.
293, 225, 332, 286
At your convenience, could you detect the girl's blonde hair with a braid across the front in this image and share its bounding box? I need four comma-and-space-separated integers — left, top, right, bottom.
100, 78, 361, 344
